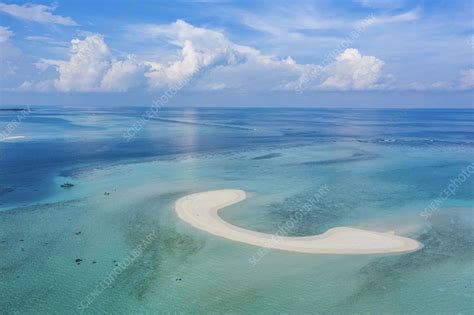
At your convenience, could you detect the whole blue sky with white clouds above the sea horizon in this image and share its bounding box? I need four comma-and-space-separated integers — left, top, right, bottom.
0, 0, 474, 108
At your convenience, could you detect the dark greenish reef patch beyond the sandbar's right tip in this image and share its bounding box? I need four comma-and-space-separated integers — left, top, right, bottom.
336, 210, 474, 312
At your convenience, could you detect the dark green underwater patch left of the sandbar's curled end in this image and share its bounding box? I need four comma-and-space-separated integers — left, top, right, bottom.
89, 192, 205, 302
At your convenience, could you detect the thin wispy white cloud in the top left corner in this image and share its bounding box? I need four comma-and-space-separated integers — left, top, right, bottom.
0, 3, 78, 26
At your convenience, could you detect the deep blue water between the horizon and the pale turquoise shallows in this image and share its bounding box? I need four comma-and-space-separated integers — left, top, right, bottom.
0, 107, 474, 209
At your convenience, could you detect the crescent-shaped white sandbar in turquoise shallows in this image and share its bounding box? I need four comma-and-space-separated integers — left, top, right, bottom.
175, 189, 422, 254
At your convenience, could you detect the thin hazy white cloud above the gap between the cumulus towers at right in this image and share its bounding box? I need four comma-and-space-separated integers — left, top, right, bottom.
235, 3, 421, 65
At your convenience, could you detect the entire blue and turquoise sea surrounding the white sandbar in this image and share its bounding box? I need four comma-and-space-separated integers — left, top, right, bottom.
0, 109, 474, 314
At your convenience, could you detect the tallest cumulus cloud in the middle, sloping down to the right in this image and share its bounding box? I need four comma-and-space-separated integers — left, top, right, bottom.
134, 20, 320, 90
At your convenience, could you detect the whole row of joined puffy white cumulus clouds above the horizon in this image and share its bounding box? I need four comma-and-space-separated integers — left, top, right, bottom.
17, 20, 387, 92
